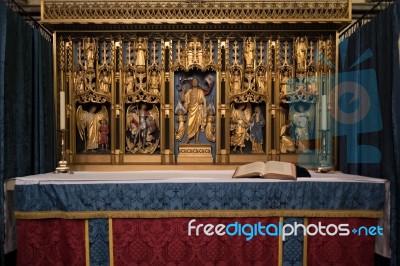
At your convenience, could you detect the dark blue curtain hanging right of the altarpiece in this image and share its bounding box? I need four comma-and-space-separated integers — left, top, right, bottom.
337, 2, 400, 265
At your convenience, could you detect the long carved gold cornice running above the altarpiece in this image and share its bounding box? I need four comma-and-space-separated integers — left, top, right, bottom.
41, 0, 351, 24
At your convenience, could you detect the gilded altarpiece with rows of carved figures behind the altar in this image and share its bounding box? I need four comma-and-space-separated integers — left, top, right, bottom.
50, 1, 347, 168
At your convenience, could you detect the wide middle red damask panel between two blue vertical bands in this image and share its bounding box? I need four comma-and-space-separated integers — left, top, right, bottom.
113, 218, 279, 266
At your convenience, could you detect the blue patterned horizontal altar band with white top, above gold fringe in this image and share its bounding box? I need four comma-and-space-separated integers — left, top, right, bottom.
15, 171, 385, 218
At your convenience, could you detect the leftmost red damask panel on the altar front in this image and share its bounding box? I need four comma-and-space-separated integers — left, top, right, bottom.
17, 219, 86, 266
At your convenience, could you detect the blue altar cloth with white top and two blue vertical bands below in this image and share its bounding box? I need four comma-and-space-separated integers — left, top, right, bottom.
12, 170, 387, 265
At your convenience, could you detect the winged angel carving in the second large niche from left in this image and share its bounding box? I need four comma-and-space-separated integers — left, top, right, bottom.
126, 103, 160, 154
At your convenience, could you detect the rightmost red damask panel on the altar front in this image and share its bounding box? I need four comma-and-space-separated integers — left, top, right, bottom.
307, 218, 377, 266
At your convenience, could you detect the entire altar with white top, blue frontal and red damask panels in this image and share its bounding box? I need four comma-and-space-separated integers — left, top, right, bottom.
7, 170, 387, 265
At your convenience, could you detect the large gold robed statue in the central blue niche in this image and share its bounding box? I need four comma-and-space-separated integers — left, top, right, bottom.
181, 78, 207, 143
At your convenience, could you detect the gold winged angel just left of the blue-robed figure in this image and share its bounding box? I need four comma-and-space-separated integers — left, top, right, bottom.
230, 103, 251, 152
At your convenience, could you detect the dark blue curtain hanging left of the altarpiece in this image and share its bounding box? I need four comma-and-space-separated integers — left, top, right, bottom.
0, 1, 56, 265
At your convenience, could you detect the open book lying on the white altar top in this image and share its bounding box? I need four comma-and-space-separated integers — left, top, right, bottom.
233, 161, 297, 180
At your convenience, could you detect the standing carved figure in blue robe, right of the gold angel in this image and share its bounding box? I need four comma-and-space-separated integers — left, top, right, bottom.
250, 106, 265, 153
